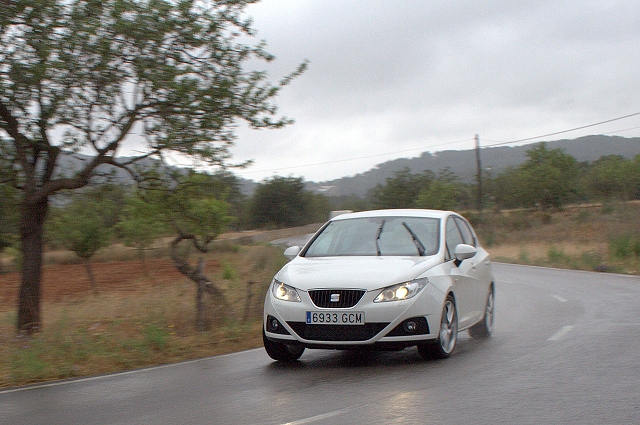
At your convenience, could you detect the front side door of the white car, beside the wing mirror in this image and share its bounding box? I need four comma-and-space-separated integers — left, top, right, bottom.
445, 216, 478, 328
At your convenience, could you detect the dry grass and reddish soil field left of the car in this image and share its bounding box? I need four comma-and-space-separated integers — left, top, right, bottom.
0, 238, 285, 387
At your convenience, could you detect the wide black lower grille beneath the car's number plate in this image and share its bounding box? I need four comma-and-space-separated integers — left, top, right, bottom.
287, 322, 389, 341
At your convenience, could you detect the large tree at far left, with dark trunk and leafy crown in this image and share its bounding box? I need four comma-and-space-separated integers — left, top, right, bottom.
0, 0, 306, 332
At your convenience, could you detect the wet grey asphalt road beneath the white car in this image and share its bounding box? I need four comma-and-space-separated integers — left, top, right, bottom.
0, 264, 640, 425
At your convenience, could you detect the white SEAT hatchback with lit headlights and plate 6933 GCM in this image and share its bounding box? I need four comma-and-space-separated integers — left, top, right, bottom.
263, 209, 495, 361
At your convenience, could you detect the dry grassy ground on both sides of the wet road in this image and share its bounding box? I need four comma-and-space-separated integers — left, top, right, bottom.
0, 204, 640, 387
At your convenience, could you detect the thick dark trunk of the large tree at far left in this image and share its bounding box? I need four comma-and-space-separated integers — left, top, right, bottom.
17, 197, 49, 333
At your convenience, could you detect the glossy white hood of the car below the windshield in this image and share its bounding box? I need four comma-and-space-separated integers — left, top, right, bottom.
276, 256, 441, 291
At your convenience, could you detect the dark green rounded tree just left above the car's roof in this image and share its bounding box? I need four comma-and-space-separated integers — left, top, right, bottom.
250, 176, 310, 227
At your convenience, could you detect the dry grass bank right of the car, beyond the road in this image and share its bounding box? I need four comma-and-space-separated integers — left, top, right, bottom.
471, 202, 640, 274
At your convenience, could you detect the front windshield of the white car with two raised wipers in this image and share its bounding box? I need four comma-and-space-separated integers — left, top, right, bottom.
302, 217, 440, 257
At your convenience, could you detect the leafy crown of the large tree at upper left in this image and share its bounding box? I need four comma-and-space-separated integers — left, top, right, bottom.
0, 0, 306, 167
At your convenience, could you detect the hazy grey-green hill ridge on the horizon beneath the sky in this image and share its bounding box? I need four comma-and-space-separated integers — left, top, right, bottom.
307, 136, 640, 197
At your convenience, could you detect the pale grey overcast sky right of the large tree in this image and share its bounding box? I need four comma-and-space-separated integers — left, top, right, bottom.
220, 0, 640, 181
